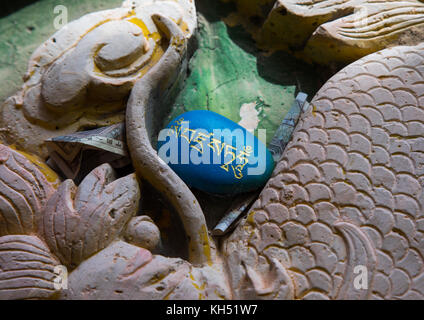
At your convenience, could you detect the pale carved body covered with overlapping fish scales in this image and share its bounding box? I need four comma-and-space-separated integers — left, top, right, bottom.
224, 45, 424, 299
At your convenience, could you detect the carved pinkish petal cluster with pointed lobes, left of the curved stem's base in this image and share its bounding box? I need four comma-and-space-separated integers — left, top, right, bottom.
43, 164, 140, 268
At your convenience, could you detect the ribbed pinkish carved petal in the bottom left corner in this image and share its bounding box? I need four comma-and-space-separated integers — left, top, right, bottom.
0, 235, 59, 300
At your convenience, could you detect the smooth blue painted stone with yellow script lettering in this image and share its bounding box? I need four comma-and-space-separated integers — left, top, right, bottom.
158, 110, 274, 195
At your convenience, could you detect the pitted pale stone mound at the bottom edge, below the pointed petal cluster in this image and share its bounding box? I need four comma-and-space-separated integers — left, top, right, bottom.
61, 241, 231, 300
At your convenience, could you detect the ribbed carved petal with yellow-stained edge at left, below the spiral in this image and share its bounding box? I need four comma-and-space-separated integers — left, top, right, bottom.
0, 144, 58, 236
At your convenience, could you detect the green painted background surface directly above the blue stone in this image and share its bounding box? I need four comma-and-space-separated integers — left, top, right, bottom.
165, 1, 319, 143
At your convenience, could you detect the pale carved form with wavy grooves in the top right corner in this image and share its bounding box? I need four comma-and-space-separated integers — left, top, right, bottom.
305, 1, 424, 63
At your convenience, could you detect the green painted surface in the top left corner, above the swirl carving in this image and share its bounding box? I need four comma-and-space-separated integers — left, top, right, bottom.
0, 0, 123, 103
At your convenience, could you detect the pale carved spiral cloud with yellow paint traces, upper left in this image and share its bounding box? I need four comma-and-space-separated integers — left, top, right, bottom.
0, 0, 196, 158
